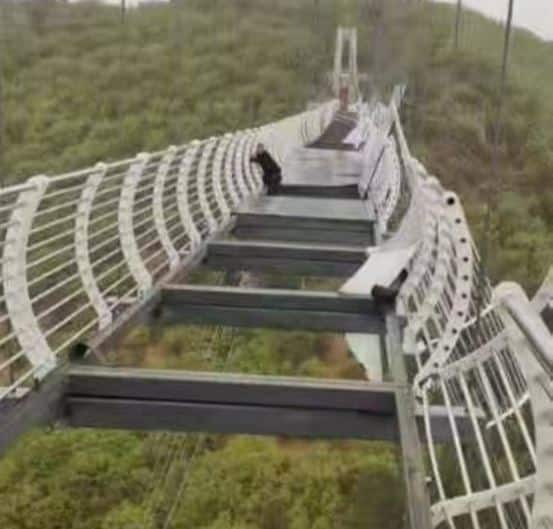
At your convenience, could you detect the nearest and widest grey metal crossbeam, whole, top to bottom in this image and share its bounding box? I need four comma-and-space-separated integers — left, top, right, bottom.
65, 367, 397, 441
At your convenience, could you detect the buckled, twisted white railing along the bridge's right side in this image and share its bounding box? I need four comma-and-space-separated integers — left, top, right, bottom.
360, 92, 553, 529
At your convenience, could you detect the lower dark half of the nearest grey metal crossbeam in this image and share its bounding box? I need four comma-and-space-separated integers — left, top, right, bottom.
66, 397, 397, 442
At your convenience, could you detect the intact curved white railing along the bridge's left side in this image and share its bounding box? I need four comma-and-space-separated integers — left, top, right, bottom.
0, 101, 337, 400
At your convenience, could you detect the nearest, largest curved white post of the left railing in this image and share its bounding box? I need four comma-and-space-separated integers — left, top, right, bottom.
2, 176, 56, 379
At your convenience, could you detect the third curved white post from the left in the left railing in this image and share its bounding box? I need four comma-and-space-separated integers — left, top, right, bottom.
119, 153, 152, 296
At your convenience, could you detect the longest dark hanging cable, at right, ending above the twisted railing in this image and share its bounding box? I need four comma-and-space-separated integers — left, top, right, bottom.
478, 0, 515, 321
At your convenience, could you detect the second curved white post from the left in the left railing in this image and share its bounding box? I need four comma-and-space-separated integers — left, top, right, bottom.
75, 163, 113, 329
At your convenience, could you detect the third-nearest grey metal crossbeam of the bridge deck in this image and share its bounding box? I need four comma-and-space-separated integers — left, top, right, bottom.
204, 240, 367, 277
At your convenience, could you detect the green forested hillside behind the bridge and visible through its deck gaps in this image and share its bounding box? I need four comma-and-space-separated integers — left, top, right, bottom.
0, 0, 553, 529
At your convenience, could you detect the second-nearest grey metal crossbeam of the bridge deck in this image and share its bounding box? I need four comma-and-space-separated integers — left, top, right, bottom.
161, 285, 384, 334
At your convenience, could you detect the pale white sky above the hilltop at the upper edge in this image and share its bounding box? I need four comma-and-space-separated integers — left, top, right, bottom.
73, 0, 553, 40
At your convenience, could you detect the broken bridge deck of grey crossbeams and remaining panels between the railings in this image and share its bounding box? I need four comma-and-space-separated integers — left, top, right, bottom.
0, 111, 426, 528
